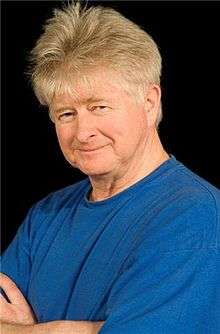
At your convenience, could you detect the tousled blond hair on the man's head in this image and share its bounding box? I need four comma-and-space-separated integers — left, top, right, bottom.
29, 1, 162, 125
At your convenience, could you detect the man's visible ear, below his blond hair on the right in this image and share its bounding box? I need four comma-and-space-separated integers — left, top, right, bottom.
145, 84, 161, 127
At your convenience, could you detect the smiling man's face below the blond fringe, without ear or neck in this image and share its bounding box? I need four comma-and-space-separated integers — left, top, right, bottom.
50, 69, 151, 178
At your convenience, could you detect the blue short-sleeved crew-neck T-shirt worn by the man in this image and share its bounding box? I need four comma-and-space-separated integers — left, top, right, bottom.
2, 157, 220, 334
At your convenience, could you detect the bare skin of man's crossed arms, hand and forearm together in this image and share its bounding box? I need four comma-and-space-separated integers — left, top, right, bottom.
0, 274, 103, 334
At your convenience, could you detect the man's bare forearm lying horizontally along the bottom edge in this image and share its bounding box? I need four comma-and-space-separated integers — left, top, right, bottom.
1, 320, 103, 334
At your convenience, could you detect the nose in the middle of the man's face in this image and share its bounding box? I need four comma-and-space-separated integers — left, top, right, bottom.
75, 113, 96, 143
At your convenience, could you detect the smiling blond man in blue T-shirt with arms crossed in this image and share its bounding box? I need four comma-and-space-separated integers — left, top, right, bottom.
1, 4, 220, 334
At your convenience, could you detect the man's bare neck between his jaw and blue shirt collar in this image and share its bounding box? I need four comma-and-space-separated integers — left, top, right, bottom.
90, 131, 169, 201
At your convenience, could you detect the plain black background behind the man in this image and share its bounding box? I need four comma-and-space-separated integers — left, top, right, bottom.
1, 1, 220, 250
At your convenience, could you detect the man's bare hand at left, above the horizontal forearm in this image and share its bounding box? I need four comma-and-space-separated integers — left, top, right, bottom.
0, 273, 36, 325
